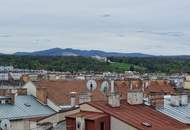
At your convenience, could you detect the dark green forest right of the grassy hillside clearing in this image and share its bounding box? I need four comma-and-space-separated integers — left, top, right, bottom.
110, 56, 190, 73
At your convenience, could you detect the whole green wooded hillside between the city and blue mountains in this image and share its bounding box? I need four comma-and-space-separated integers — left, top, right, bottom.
0, 55, 190, 73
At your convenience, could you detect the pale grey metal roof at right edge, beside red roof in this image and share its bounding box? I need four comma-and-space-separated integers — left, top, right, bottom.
158, 98, 190, 124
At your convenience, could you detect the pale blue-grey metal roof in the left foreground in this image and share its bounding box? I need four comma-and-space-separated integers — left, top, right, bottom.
0, 96, 55, 120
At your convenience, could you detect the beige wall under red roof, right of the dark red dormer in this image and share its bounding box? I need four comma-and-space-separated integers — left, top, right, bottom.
110, 117, 137, 130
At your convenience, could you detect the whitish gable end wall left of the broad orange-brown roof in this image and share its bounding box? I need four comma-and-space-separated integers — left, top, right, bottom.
23, 82, 36, 97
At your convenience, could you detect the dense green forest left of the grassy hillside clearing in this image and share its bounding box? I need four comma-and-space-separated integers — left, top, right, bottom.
0, 56, 109, 72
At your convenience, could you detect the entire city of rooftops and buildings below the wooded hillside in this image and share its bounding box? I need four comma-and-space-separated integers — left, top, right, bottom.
0, 67, 190, 130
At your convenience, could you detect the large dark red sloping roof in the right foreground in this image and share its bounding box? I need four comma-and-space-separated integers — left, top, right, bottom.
88, 100, 190, 130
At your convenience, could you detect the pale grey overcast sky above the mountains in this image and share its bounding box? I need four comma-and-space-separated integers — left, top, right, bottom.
0, 0, 190, 55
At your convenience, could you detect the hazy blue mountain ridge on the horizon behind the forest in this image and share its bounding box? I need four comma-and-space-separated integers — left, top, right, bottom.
13, 48, 153, 57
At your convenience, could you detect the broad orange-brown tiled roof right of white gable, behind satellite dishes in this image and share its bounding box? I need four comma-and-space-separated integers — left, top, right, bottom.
34, 80, 106, 105
